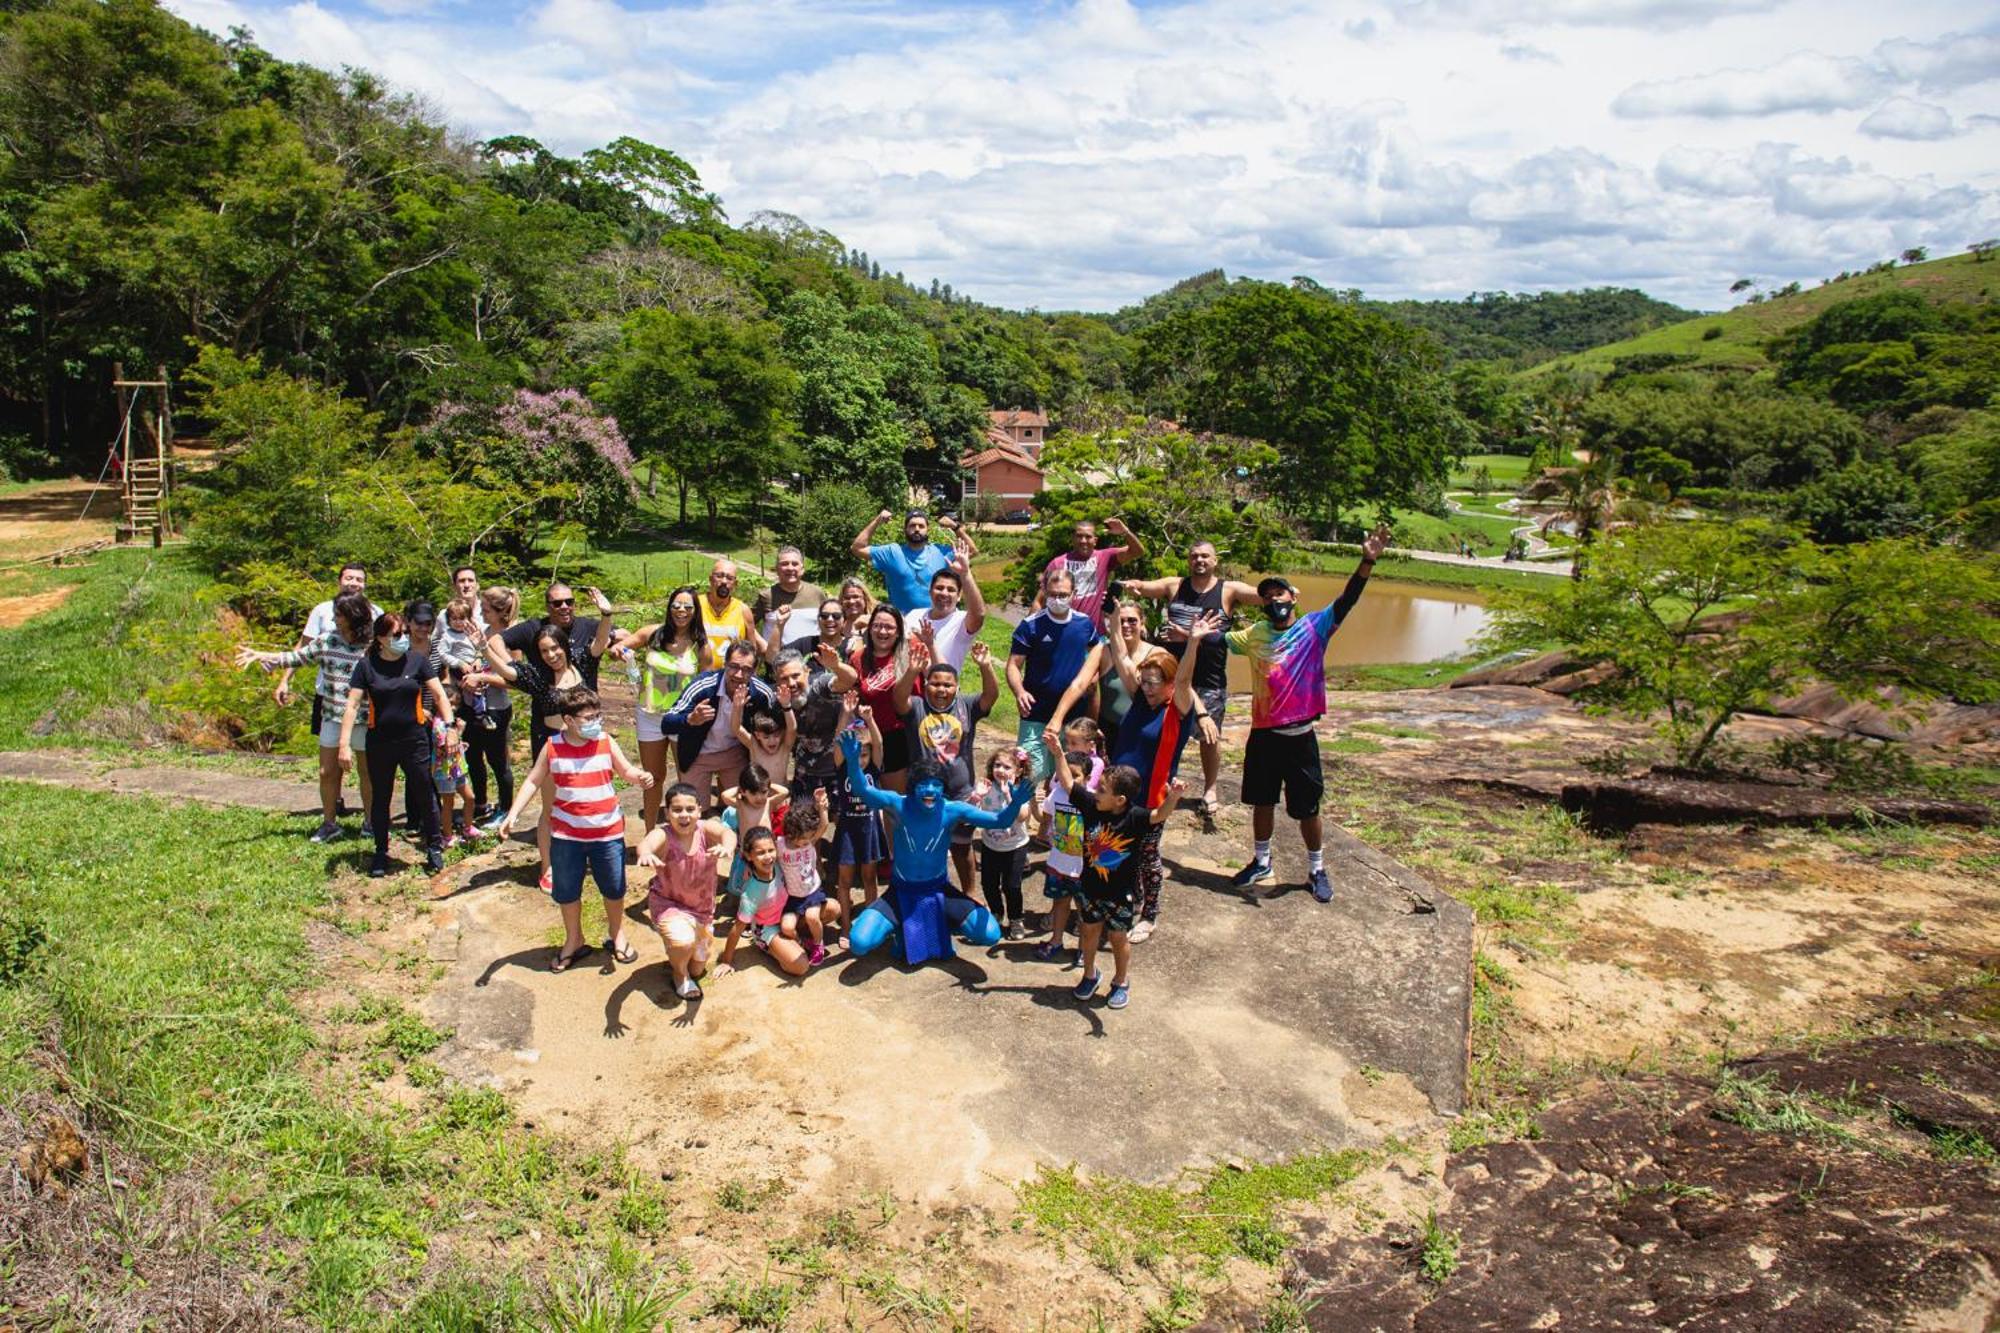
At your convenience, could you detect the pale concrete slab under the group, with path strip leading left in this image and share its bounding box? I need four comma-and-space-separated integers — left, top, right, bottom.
0, 736, 1472, 1197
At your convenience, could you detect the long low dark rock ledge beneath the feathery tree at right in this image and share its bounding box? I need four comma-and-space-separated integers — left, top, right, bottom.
1562, 773, 1994, 831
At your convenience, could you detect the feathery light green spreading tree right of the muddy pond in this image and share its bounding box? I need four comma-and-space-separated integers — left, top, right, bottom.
1482, 522, 2000, 769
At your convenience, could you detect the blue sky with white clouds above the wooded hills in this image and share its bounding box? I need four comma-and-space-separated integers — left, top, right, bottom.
166, 0, 2000, 310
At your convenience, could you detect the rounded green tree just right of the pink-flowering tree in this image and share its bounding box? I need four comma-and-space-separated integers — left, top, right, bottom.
590, 310, 796, 532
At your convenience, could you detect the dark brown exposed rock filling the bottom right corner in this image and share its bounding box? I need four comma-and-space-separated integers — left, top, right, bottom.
1290, 1039, 2000, 1331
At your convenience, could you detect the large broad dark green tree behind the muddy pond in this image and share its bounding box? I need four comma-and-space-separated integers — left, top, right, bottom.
1136, 284, 1474, 530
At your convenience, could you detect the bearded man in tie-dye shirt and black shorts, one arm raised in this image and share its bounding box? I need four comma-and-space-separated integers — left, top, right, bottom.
1222, 524, 1388, 903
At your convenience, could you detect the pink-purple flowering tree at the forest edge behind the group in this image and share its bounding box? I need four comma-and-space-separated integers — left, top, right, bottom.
426, 388, 636, 554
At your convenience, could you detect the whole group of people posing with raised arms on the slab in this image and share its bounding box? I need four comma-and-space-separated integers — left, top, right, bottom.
240, 510, 1388, 1009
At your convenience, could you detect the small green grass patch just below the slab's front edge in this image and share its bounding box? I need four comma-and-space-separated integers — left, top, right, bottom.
1020, 1149, 1370, 1271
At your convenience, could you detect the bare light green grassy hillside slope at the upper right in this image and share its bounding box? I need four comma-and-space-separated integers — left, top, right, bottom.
1522, 254, 2000, 380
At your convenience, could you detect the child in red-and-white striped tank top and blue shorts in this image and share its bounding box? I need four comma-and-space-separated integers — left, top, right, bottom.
500, 685, 652, 973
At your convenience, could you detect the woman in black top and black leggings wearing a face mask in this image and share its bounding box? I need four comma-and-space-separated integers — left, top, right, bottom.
340, 612, 452, 879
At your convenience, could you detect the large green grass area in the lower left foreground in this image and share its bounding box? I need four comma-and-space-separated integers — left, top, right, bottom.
0, 783, 708, 1329
